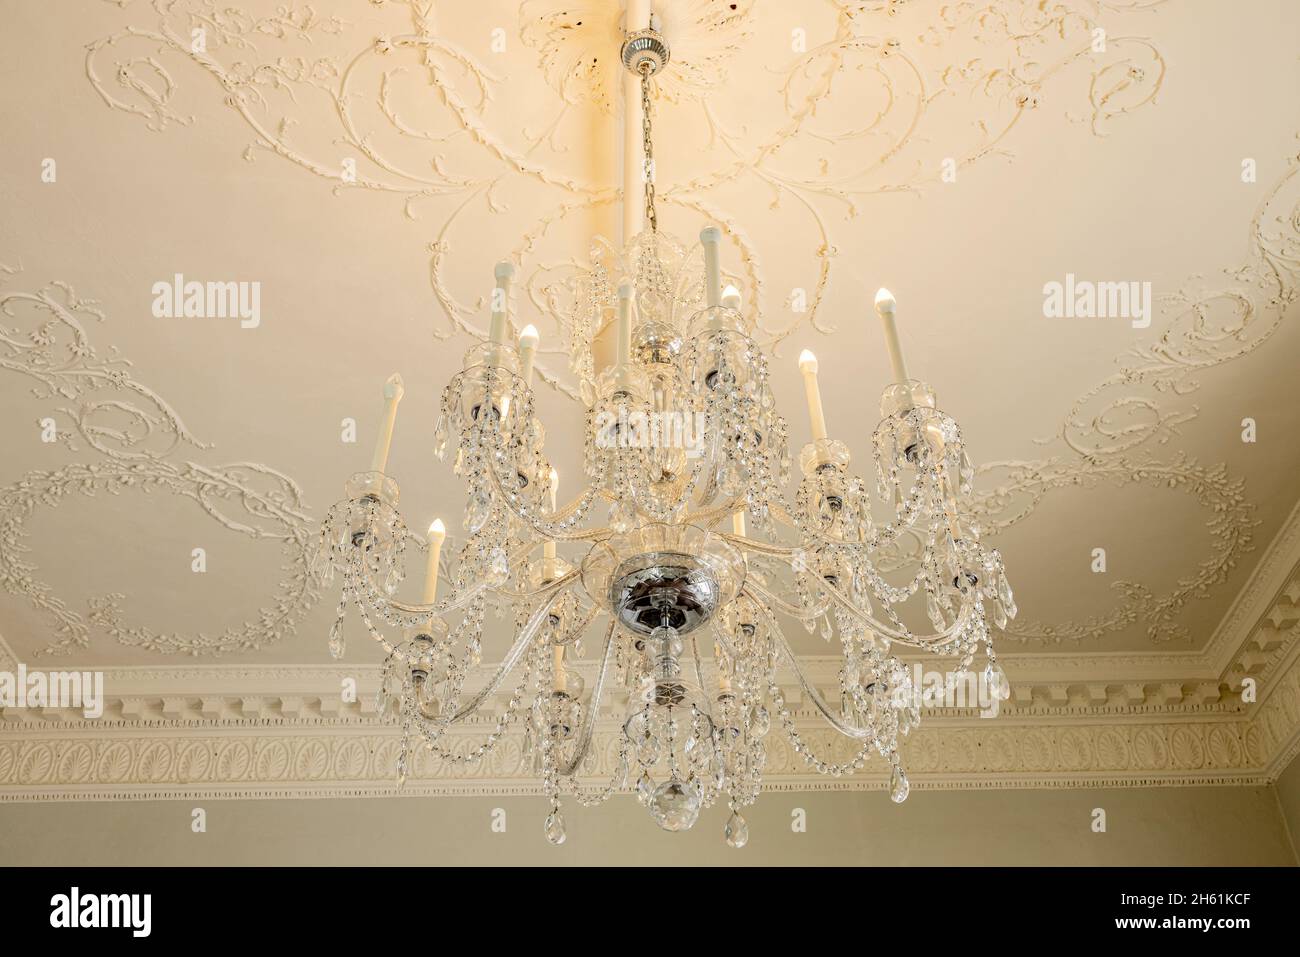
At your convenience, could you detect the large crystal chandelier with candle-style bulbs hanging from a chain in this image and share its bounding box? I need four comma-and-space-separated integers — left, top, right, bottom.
321, 20, 1015, 846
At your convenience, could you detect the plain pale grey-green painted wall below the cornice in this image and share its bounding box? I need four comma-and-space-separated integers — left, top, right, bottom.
0, 785, 1300, 866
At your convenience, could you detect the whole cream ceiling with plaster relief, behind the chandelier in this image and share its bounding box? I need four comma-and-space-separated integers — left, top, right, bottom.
0, 0, 1300, 800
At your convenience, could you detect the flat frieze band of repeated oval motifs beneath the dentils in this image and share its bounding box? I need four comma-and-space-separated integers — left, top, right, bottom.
0, 719, 1271, 801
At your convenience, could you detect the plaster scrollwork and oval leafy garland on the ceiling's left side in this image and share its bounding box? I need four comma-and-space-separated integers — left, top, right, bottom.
0, 267, 319, 655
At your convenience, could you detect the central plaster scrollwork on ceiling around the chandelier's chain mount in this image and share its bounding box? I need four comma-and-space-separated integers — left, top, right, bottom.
86, 0, 1165, 382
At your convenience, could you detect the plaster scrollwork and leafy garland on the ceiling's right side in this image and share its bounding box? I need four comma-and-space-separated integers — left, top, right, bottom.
980, 145, 1300, 642
